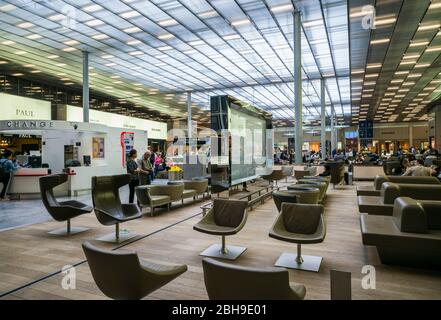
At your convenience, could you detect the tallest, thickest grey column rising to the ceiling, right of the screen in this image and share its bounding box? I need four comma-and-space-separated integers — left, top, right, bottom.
294, 11, 303, 164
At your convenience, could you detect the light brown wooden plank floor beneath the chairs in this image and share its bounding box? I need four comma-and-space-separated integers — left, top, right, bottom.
0, 180, 441, 300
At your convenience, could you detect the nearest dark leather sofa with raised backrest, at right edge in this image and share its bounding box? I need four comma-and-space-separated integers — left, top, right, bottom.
360, 197, 441, 270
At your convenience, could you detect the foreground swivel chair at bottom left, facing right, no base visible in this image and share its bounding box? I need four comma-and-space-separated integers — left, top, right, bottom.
83, 242, 187, 300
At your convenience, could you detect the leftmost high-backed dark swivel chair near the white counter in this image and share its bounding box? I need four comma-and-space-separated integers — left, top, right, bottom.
39, 173, 93, 235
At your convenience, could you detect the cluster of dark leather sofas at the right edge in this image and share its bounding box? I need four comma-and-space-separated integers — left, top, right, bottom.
357, 176, 441, 270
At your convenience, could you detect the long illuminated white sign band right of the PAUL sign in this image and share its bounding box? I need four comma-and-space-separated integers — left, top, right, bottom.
66, 105, 167, 140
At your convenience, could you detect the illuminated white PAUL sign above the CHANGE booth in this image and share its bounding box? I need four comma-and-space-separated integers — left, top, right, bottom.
0, 93, 52, 120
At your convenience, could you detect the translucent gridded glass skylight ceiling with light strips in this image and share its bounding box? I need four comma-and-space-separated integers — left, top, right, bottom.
0, 0, 351, 125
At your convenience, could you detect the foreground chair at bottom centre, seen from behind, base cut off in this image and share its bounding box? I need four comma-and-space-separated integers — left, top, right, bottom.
202, 258, 306, 300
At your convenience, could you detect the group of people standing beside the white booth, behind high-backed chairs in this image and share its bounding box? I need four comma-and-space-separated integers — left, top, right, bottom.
127, 148, 169, 203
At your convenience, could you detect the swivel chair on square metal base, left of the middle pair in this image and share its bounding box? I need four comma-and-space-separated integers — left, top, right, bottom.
193, 199, 248, 260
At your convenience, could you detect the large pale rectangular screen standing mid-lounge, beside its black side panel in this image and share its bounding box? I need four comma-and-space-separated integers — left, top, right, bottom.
228, 104, 267, 185
